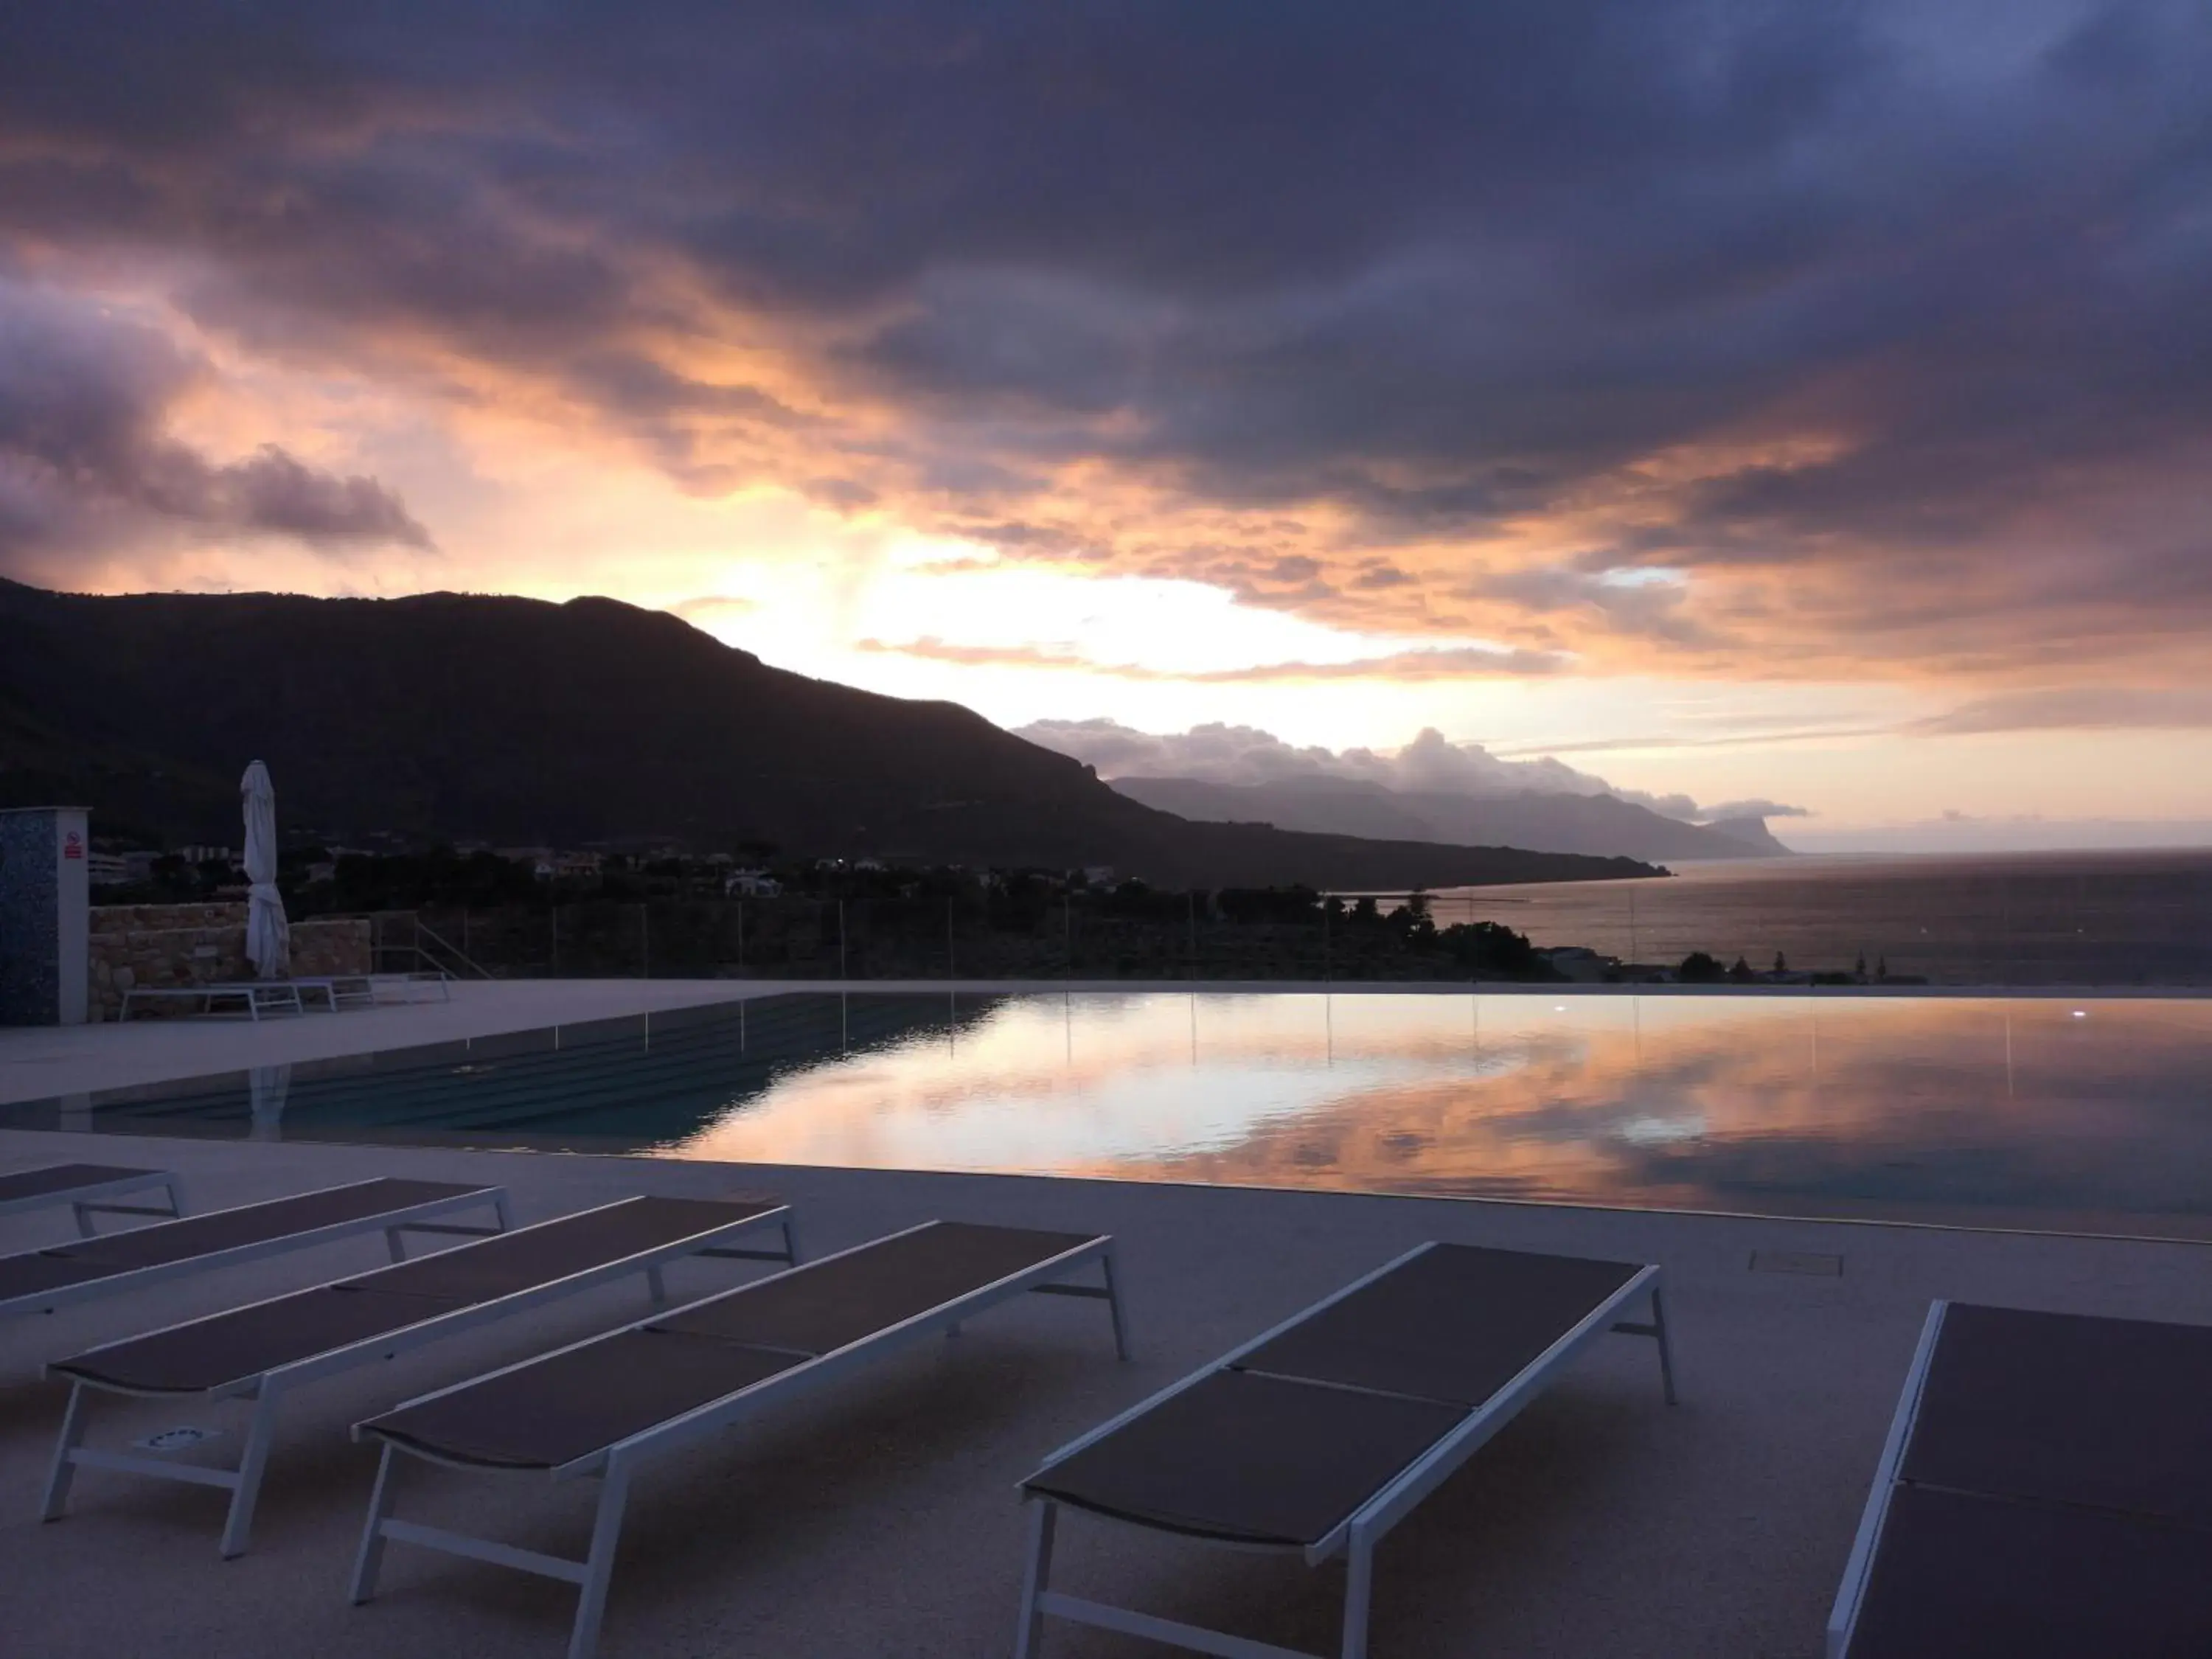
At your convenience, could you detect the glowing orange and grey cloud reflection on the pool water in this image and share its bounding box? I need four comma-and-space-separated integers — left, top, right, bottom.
659, 993, 2212, 1232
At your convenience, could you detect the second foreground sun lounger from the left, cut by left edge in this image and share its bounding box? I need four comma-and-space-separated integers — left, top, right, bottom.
0, 1177, 507, 1316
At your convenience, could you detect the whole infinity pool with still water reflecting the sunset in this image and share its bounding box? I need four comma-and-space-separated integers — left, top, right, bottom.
17, 991, 2212, 1237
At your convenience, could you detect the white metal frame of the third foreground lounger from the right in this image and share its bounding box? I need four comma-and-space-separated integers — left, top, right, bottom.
352, 1223, 1130, 1659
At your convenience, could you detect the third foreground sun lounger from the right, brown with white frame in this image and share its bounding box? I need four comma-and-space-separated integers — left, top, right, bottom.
354, 1221, 1128, 1659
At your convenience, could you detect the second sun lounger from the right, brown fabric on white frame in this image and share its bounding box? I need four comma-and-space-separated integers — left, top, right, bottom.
1015, 1243, 1674, 1659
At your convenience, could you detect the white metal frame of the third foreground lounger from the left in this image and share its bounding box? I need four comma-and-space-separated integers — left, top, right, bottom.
40, 1203, 799, 1562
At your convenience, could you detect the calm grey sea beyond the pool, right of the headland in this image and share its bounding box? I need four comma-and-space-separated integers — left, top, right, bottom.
1431, 847, 2212, 987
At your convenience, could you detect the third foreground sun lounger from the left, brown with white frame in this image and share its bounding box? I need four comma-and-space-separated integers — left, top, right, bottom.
44, 1199, 796, 1559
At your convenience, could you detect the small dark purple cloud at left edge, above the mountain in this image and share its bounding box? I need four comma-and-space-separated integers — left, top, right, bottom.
0, 279, 429, 575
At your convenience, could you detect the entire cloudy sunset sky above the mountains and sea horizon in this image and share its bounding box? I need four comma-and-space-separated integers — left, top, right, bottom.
0, 0, 2212, 847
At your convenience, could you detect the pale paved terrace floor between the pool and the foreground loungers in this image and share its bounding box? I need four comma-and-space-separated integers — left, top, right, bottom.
0, 1130, 2212, 1659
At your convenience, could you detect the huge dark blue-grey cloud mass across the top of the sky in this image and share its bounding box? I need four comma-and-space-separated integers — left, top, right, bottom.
0, 0, 2212, 666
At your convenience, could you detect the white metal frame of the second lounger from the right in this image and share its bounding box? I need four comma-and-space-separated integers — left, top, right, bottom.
1013, 1241, 1674, 1659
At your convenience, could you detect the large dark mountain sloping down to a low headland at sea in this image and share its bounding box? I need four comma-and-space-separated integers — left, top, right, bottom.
0, 582, 1657, 889
